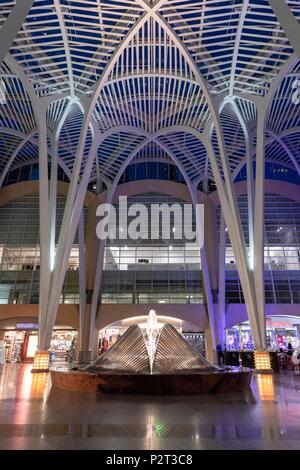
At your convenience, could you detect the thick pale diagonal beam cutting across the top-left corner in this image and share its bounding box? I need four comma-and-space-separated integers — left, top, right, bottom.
0, 0, 34, 65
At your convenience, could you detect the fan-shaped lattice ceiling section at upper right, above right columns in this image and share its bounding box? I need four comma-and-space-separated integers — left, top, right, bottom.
162, 0, 300, 94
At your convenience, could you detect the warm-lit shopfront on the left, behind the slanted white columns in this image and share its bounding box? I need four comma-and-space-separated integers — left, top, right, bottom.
0, 322, 77, 363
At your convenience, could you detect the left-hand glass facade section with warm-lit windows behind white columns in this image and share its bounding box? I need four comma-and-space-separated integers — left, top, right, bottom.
0, 195, 79, 304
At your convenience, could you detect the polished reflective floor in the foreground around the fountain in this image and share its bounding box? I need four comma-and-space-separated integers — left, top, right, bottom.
0, 364, 300, 450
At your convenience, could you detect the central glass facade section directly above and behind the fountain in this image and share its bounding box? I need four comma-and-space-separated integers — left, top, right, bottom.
102, 193, 203, 304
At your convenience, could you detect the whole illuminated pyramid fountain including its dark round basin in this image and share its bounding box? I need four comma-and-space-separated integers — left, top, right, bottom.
51, 310, 253, 394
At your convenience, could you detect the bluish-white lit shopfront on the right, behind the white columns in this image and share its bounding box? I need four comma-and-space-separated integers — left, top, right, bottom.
226, 315, 300, 351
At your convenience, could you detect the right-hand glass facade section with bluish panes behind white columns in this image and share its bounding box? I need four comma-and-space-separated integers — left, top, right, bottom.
220, 194, 300, 303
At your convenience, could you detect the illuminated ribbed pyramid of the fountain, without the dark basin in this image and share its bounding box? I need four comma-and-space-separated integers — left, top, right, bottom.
82, 310, 220, 375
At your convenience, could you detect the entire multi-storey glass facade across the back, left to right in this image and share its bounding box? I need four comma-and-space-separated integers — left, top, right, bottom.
0, 193, 300, 304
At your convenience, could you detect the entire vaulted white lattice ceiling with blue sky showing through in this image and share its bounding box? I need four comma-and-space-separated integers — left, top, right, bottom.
0, 0, 300, 187
